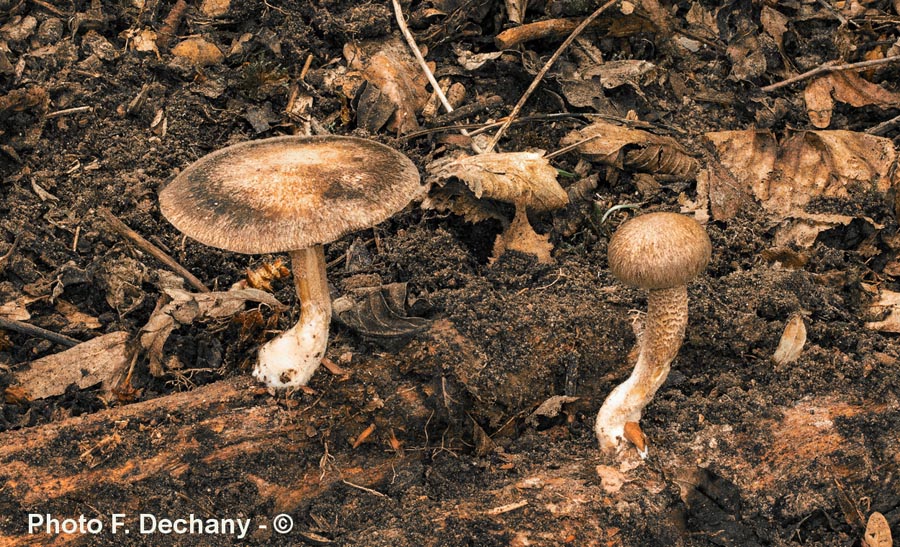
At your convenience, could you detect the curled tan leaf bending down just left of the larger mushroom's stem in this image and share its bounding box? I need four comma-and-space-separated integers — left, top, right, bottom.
139, 288, 284, 376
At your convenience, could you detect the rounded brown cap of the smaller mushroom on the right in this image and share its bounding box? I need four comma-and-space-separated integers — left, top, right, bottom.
607, 213, 712, 289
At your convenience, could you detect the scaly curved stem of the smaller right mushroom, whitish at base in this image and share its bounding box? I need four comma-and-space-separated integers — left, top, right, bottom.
594, 285, 688, 456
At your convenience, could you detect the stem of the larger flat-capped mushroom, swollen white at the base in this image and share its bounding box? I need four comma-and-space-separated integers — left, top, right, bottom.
253, 245, 331, 388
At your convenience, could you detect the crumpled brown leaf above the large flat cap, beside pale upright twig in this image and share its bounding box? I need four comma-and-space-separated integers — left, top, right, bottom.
344, 37, 430, 133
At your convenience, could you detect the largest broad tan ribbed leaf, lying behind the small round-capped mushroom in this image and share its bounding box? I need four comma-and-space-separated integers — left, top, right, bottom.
706, 130, 896, 217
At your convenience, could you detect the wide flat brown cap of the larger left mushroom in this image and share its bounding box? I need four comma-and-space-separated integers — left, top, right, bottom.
159, 136, 422, 254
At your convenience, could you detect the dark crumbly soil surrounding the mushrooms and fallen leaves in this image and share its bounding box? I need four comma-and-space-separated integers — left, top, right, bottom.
0, 0, 900, 547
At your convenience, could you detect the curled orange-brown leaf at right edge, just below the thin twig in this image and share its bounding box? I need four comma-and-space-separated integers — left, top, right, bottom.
803, 71, 900, 129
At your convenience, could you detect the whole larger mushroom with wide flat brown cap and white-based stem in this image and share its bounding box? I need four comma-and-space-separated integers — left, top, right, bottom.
159, 136, 422, 388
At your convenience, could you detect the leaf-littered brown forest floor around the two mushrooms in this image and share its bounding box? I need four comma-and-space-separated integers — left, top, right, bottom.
0, 0, 900, 547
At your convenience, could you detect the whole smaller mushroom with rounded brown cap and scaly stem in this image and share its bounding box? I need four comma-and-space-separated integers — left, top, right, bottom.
594, 213, 712, 456
